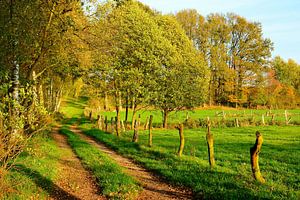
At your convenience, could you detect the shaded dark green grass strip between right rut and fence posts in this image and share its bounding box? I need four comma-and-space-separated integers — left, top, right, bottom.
83, 129, 262, 199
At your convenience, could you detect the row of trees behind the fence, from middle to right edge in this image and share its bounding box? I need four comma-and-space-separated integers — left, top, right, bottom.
86, 0, 300, 130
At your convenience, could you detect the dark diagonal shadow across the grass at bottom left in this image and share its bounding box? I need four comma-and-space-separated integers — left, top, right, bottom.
14, 165, 79, 200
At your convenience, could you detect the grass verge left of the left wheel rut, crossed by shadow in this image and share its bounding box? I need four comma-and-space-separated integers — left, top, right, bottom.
0, 133, 63, 200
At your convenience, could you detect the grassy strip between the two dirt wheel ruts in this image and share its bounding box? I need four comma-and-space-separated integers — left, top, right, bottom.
60, 126, 140, 199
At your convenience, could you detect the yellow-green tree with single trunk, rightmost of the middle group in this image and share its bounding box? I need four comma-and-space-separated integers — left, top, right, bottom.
152, 16, 209, 128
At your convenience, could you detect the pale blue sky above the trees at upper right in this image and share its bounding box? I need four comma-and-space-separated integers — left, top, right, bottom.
140, 0, 300, 64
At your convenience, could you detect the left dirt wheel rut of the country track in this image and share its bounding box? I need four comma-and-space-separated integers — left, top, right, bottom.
51, 127, 105, 200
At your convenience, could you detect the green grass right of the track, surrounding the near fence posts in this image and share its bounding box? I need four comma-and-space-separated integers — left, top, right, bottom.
61, 96, 300, 199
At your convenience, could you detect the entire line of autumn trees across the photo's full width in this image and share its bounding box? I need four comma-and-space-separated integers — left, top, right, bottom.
0, 0, 300, 136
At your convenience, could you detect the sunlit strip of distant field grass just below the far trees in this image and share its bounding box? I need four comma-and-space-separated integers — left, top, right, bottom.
85, 101, 300, 127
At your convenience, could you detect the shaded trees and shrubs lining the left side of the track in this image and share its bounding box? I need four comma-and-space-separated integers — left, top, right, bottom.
0, 0, 87, 170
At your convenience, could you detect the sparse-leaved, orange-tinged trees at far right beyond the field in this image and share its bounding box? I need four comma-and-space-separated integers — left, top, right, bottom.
176, 10, 300, 106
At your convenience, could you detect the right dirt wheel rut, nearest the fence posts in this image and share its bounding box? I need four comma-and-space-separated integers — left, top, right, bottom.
71, 126, 192, 200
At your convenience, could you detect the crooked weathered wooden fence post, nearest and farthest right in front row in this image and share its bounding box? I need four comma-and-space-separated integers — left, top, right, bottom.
250, 131, 266, 183
